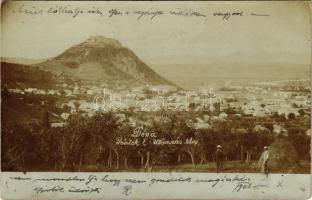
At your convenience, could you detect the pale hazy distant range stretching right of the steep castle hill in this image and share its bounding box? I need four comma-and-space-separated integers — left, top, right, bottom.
150, 61, 310, 90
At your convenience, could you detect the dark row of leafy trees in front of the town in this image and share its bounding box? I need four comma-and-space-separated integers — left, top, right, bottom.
1, 112, 310, 171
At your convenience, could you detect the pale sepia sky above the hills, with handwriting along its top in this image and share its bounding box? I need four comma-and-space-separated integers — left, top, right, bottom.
1, 1, 311, 64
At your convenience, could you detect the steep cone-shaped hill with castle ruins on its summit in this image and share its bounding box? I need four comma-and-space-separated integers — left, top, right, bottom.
34, 36, 173, 85
